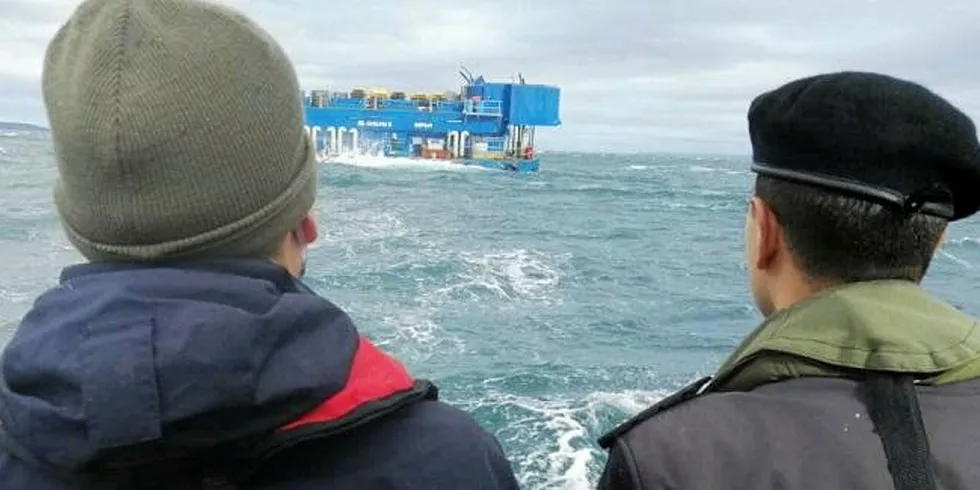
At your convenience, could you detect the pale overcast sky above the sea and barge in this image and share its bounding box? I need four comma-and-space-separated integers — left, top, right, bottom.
0, 0, 980, 153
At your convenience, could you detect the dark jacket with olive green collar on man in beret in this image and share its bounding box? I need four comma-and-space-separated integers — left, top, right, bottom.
599, 281, 980, 490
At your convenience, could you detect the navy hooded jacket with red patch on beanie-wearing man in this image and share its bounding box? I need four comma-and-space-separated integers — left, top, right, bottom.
0, 261, 518, 490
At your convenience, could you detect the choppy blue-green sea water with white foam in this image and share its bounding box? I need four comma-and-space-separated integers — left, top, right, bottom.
0, 128, 980, 490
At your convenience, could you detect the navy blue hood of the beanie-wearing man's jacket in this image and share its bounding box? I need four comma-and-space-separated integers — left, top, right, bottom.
0, 260, 407, 469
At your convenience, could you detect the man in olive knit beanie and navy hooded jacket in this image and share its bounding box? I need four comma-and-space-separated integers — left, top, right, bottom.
0, 0, 517, 490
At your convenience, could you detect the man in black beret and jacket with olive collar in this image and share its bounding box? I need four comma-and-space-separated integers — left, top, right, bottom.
599, 72, 980, 490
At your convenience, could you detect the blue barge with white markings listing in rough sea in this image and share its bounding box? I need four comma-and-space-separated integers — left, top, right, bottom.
304, 68, 561, 172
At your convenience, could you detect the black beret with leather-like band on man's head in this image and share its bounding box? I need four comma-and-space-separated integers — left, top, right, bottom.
748, 72, 980, 221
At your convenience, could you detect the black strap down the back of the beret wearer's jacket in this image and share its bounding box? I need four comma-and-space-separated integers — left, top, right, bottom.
861, 372, 936, 490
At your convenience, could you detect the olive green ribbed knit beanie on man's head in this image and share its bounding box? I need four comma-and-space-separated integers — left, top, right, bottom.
43, 0, 316, 261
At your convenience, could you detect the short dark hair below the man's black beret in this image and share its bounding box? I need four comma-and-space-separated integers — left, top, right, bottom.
755, 176, 946, 283
